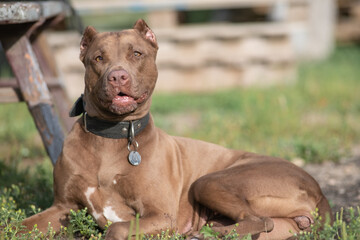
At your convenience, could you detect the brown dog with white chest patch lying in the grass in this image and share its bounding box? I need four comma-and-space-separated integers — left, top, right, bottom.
24, 20, 331, 239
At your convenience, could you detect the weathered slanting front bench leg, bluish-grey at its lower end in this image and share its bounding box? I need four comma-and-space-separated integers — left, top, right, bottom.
1, 36, 64, 164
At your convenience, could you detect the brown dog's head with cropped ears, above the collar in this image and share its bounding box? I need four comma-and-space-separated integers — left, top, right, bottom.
80, 19, 158, 121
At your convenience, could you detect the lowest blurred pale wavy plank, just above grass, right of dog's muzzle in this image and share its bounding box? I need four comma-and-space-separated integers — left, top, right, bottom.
156, 63, 296, 92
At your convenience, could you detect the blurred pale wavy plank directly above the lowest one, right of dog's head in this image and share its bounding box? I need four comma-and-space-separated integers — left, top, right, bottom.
157, 37, 295, 69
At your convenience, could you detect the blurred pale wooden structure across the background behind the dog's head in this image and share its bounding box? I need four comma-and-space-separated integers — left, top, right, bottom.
40, 0, 354, 97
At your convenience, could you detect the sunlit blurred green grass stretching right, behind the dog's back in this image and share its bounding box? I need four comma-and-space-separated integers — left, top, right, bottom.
152, 47, 360, 162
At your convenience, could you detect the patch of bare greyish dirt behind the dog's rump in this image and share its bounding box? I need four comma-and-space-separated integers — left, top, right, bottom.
304, 148, 360, 212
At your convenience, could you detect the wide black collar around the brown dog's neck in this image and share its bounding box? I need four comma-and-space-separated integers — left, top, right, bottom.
69, 95, 150, 139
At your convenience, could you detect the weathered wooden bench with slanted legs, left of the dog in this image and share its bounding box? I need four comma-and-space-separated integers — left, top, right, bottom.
0, 1, 74, 164
